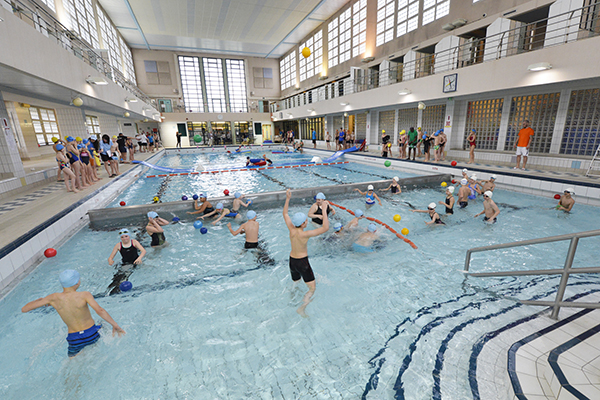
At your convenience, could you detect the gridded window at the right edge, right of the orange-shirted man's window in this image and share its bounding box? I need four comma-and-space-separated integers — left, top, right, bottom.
560, 89, 600, 156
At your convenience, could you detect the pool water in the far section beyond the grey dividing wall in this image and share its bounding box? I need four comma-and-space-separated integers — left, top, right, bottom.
109, 153, 416, 207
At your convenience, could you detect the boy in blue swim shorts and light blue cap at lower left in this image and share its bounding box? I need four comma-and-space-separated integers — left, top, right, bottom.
21, 269, 125, 357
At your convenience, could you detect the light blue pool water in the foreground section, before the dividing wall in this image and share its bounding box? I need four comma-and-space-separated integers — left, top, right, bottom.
0, 188, 600, 400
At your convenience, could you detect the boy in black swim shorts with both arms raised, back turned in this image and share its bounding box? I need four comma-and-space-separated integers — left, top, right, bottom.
283, 189, 329, 316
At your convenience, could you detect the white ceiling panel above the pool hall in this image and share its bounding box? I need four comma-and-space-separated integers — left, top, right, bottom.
99, 0, 349, 58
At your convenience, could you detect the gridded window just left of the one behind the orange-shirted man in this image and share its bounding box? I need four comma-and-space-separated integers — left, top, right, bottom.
463, 99, 504, 150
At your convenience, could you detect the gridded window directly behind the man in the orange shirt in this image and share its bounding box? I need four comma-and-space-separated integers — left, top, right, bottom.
504, 93, 560, 153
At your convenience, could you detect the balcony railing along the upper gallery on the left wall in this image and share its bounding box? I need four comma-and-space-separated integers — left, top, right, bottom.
0, 0, 152, 108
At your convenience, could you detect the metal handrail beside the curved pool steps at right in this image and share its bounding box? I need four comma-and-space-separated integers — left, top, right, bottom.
463, 229, 600, 319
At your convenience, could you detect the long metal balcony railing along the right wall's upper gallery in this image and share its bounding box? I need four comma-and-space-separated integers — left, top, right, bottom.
271, 2, 600, 114
